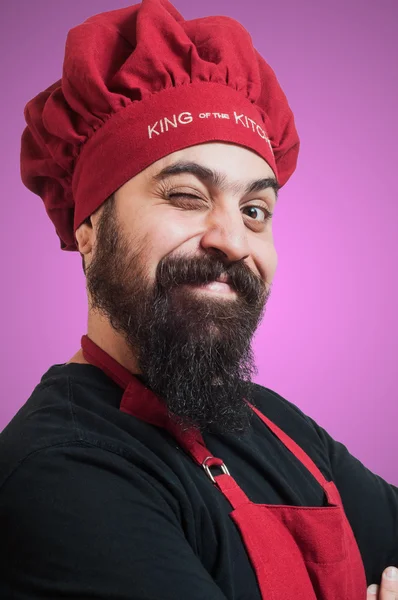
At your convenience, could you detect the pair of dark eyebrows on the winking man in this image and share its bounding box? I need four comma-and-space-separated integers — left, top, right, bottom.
153, 161, 280, 200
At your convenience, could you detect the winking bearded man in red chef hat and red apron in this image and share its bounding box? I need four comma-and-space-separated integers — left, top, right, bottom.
0, 0, 398, 600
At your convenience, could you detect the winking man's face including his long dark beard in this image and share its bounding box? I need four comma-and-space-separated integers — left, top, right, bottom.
82, 143, 277, 433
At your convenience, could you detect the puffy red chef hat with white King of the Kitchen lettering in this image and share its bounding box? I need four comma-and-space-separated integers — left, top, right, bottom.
21, 0, 299, 250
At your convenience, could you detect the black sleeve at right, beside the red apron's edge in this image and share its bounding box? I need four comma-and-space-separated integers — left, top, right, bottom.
310, 419, 398, 584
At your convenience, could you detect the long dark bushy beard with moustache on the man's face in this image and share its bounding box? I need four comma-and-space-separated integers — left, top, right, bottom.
86, 199, 270, 433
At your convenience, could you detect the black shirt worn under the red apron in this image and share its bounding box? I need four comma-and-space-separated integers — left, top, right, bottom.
0, 364, 398, 600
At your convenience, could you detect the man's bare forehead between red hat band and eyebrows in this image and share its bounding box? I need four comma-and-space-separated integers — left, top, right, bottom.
146, 142, 275, 183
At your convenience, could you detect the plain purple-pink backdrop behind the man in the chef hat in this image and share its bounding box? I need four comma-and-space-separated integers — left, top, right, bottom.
0, 0, 398, 485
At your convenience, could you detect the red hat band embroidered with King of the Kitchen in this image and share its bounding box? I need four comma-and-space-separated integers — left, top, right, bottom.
72, 82, 278, 231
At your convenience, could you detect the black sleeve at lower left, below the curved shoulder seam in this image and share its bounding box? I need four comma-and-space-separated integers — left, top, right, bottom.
0, 443, 229, 600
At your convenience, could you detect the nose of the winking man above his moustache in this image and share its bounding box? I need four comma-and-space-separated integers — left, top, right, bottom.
201, 207, 250, 262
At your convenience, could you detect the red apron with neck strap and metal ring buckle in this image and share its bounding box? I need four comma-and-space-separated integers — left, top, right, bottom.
81, 335, 366, 600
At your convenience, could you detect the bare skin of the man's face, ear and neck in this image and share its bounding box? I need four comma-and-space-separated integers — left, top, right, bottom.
68, 143, 277, 373
